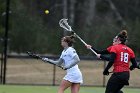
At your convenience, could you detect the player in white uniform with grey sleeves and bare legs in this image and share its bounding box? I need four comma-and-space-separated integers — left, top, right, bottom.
42, 36, 83, 93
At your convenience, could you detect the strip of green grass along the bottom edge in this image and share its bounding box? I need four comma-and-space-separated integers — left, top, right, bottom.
0, 85, 140, 93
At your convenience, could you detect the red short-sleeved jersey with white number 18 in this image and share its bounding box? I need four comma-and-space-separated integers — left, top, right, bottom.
107, 44, 135, 72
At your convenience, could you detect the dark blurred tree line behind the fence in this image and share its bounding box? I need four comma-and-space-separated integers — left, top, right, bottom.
0, 0, 140, 56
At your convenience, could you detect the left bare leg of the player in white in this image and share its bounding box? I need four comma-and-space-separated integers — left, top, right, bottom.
58, 79, 72, 93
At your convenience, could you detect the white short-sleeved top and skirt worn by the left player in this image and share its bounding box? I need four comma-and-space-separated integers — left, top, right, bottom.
60, 47, 83, 83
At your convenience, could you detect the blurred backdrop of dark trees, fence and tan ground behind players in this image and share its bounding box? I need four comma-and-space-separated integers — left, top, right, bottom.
0, 0, 140, 87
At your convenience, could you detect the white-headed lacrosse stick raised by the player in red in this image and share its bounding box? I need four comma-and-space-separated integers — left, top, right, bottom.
59, 18, 97, 56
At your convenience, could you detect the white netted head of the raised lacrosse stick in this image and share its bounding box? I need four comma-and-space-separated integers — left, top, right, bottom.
59, 18, 73, 32
